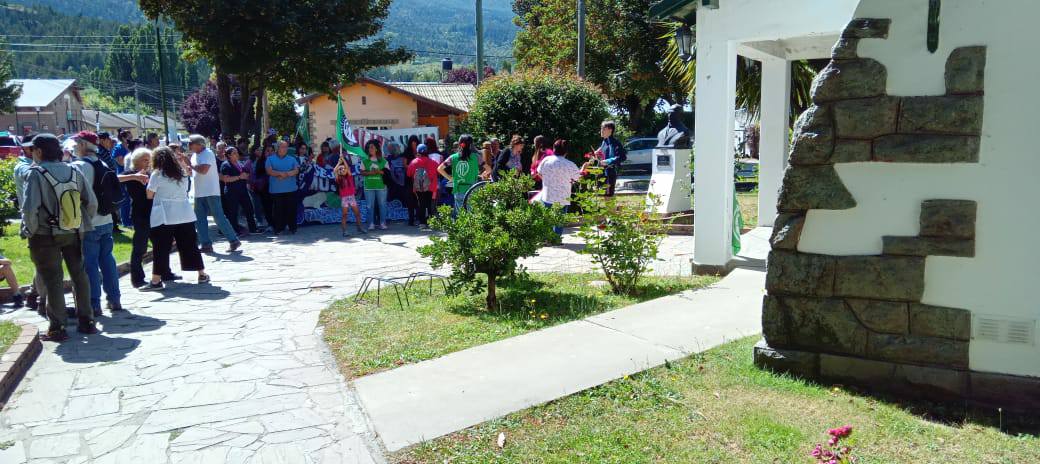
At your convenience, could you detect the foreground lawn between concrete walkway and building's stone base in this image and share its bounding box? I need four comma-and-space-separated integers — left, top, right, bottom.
391, 336, 1040, 464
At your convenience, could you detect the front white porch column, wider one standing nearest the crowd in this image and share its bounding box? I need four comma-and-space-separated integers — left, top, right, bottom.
694, 37, 736, 274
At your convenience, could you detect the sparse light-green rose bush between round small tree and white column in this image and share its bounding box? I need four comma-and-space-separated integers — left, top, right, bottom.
577, 180, 668, 294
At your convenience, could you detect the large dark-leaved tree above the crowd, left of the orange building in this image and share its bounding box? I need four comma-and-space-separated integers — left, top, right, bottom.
139, 0, 409, 139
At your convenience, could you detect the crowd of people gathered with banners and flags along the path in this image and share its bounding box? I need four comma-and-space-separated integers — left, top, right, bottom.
6, 121, 625, 341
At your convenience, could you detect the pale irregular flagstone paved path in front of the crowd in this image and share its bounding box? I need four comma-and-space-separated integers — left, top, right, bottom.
0, 222, 693, 464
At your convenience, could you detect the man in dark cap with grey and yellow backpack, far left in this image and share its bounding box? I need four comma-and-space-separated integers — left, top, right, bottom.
22, 134, 98, 341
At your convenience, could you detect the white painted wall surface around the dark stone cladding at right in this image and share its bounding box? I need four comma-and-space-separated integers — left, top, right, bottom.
794, 0, 1040, 377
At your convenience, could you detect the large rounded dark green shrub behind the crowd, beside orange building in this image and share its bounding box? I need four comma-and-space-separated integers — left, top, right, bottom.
467, 72, 608, 157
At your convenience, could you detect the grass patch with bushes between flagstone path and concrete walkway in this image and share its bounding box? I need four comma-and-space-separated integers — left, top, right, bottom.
321, 274, 717, 378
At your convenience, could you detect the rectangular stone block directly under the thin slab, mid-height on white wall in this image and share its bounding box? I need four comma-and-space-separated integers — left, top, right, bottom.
834, 256, 925, 302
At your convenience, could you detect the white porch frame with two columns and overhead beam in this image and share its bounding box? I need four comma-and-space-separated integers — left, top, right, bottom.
694, 0, 859, 266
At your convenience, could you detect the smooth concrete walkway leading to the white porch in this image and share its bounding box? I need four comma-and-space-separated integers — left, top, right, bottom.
354, 229, 770, 452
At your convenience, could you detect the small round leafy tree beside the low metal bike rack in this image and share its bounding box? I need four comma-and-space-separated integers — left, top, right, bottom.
419, 175, 567, 310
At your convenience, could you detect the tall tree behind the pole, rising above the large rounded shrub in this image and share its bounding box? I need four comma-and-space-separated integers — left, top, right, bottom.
514, 0, 688, 134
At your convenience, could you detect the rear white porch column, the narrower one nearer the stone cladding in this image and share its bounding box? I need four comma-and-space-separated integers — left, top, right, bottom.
758, 57, 790, 227
